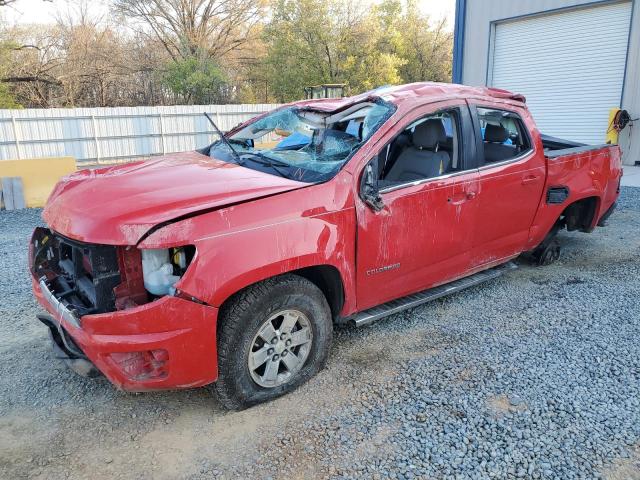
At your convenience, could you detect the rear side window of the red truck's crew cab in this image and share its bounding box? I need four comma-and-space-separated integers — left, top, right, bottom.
477, 107, 531, 164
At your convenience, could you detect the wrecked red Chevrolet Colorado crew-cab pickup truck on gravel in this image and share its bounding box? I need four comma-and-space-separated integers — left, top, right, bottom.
30, 83, 622, 409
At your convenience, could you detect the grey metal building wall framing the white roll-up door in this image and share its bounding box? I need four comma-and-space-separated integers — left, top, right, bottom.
462, 0, 640, 164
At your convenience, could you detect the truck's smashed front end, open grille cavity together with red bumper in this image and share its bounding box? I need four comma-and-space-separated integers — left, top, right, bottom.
30, 228, 218, 391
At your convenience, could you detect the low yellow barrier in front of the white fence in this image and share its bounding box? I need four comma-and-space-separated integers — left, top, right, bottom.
0, 157, 76, 207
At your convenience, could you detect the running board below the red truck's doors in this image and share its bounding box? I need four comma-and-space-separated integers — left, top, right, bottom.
350, 262, 518, 327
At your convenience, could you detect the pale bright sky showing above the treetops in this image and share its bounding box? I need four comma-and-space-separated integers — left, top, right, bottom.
2, 0, 456, 30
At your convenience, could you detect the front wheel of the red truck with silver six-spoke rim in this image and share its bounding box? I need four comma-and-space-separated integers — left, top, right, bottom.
215, 274, 333, 410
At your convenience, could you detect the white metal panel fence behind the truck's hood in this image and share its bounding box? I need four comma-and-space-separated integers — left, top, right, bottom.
0, 104, 277, 165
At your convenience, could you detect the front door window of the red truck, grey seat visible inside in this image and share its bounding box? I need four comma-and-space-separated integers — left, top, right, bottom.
378, 109, 462, 188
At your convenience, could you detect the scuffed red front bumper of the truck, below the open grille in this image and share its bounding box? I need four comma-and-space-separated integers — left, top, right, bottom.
32, 278, 218, 391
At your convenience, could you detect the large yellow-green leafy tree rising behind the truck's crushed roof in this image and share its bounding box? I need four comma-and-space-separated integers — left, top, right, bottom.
263, 0, 403, 101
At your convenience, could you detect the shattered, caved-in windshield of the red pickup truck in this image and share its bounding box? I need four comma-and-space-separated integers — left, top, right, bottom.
209, 100, 395, 183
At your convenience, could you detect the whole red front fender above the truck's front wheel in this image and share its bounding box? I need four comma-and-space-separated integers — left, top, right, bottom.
139, 174, 356, 313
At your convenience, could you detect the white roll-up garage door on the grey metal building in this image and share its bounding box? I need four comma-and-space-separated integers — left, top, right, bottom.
489, 1, 632, 144
